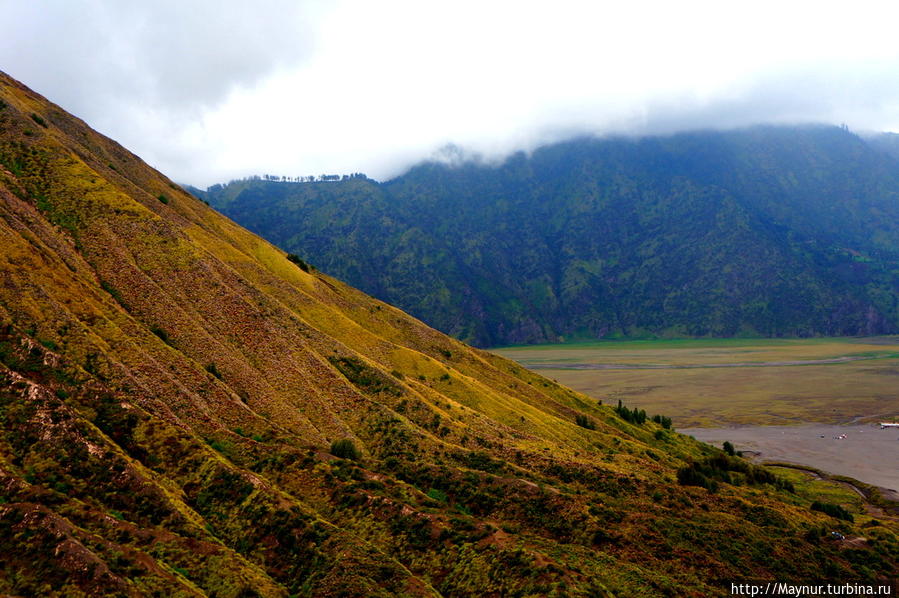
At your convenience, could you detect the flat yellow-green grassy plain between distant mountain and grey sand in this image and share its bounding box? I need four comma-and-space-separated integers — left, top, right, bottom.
496, 337, 899, 427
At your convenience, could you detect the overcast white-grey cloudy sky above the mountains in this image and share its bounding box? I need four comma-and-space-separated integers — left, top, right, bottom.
0, 0, 899, 187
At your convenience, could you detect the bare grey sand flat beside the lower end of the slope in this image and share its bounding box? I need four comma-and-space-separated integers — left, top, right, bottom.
678, 424, 899, 491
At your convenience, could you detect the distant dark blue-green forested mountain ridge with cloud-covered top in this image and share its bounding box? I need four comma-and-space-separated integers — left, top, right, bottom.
202, 126, 899, 346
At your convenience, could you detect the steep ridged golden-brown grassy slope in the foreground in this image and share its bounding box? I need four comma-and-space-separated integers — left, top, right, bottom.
0, 76, 899, 596
